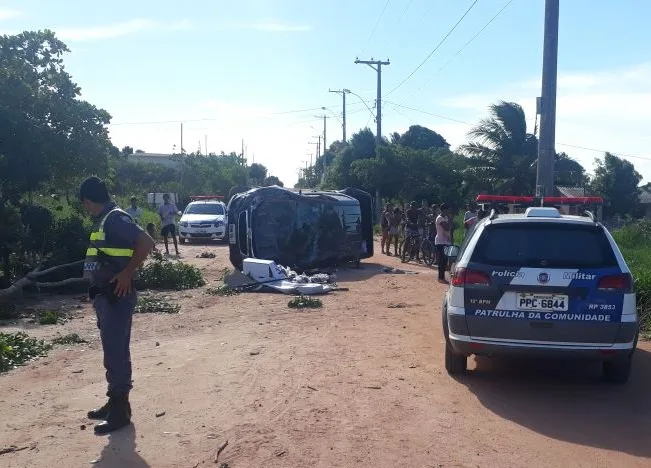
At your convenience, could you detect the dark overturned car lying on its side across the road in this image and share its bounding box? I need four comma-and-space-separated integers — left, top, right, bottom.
227, 186, 373, 271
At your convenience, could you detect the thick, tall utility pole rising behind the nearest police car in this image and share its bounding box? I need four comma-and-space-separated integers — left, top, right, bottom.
536, 0, 559, 197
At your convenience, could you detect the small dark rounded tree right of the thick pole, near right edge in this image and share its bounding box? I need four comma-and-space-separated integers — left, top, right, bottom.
590, 153, 642, 217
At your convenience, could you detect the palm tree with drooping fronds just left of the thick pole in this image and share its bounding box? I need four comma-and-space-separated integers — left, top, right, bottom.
459, 101, 538, 195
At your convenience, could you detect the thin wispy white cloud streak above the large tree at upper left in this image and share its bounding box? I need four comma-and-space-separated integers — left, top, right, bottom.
55, 19, 191, 42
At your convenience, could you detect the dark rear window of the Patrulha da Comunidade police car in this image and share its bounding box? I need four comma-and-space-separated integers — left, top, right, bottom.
470, 223, 617, 268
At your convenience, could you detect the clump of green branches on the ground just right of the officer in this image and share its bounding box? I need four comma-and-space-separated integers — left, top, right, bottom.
137, 254, 206, 291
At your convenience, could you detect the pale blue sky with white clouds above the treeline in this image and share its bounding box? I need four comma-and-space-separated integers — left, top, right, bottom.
0, 0, 651, 185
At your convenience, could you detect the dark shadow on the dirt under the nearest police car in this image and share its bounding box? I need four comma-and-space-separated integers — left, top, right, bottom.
461, 349, 651, 457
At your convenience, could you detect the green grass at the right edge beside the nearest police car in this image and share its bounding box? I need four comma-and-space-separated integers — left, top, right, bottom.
613, 220, 651, 339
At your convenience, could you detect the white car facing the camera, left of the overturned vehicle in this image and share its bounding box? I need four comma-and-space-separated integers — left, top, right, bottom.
179, 200, 226, 242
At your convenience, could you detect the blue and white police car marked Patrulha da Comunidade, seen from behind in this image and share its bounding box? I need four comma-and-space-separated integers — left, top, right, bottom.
442, 207, 639, 383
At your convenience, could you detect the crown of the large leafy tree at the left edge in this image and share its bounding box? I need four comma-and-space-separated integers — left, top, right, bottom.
0, 30, 113, 202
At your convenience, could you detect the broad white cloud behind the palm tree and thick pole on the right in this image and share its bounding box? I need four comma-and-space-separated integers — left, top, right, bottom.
441, 63, 651, 181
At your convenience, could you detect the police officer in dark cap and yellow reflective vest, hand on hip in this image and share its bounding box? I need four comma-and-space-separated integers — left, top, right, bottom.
79, 177, 154, 434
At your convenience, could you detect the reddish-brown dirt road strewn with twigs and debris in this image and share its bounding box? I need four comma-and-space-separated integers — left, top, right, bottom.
0, 246, 651, 468
